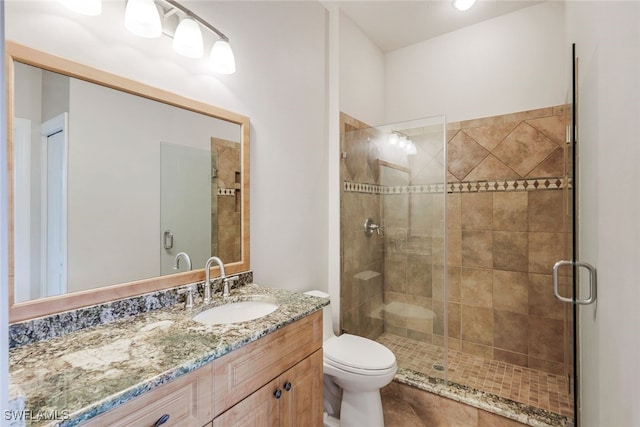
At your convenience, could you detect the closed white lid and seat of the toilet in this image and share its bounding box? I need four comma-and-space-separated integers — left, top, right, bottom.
322, 334, 396, 375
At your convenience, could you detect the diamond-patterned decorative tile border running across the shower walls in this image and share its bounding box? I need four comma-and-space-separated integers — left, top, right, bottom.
343, 177, 573, 194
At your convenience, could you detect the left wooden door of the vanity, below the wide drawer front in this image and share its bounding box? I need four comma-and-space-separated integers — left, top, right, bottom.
213, 379, 282, 427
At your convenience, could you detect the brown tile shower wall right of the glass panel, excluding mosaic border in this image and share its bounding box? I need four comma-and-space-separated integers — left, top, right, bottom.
442, 106, 571, 374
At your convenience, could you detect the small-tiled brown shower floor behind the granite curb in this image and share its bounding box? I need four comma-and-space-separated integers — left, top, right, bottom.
377, 332, 573, 417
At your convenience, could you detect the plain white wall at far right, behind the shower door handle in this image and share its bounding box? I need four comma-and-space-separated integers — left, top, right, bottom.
567, 1, 640, 427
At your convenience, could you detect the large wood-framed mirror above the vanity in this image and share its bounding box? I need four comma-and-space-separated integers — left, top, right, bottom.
6, 42, 250, 322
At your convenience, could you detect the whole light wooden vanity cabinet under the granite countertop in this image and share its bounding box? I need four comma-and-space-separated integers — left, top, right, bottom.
83, 311, 322, 427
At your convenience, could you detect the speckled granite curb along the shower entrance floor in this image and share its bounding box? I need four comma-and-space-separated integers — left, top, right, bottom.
394, 368, 573, 427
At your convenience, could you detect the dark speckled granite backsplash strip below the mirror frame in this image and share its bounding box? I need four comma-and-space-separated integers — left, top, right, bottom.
9, 271, 253, 349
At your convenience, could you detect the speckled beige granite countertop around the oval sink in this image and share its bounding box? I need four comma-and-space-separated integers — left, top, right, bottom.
9, 284, 328, 426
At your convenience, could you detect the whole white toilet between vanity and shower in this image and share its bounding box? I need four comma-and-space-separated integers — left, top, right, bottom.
305, 291, 397, 427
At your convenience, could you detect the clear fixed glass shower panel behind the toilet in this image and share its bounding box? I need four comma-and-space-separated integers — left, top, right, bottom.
341, 111, 448, 381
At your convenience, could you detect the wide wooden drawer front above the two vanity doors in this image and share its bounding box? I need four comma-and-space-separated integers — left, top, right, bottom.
214, 310, 322, 416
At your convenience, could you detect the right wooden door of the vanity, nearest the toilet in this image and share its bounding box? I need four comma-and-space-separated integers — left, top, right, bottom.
279, 350, 322, 427
